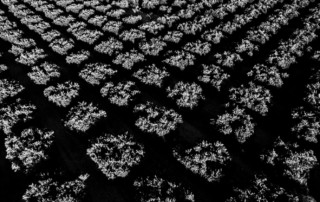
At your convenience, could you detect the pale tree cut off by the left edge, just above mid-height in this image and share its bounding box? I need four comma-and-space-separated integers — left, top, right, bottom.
0, 79, 24, 103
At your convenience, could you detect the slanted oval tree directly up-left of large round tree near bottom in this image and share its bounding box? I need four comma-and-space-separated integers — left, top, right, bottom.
64, 101, 107, 132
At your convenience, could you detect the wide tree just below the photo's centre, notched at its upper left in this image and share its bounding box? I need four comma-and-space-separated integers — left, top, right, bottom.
133, 102, 182, 137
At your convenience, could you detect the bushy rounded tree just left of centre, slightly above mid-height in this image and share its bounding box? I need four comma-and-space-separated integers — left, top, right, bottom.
100, 81, 140, 106
